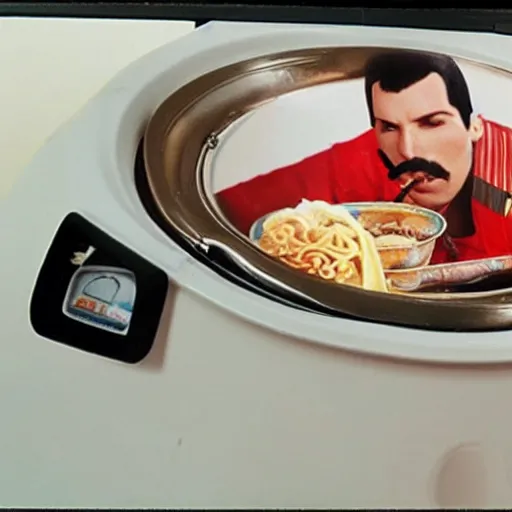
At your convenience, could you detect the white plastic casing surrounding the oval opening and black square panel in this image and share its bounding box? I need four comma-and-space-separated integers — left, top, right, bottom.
0, 19, 512, 508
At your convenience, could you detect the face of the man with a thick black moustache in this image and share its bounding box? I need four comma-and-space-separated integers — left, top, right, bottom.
372, 73, 472, 210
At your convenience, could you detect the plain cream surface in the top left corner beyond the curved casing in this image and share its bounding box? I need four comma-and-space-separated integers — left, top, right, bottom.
0, 18, 194, 200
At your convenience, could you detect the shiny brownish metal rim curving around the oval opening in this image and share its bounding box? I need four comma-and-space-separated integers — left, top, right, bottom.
144, 47, 512, 331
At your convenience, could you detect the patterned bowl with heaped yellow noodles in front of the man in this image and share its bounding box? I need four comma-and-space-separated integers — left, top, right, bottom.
249, 200, 446, 291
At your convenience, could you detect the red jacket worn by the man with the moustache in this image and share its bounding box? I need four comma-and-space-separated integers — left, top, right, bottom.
217, 119, 512, 263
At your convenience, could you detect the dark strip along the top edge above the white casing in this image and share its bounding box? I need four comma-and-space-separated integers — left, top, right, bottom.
0, 4, 512, 34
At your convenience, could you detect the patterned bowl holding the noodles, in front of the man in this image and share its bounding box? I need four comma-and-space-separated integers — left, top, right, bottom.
249, 202, 446, 271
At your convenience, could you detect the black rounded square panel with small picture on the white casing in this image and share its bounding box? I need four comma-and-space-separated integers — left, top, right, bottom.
30, 213, 169, 363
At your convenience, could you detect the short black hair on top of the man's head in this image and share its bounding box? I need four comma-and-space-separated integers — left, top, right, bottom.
365, 50, 473, 129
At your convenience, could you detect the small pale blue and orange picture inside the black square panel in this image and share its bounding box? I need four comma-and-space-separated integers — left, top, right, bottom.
62, 247, 136, 335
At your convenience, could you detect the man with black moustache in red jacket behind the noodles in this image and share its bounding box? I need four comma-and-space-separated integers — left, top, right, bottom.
217, 50, 512, 264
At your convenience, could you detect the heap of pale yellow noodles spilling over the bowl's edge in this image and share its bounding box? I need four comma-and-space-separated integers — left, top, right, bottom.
259, 201, 387, 291
